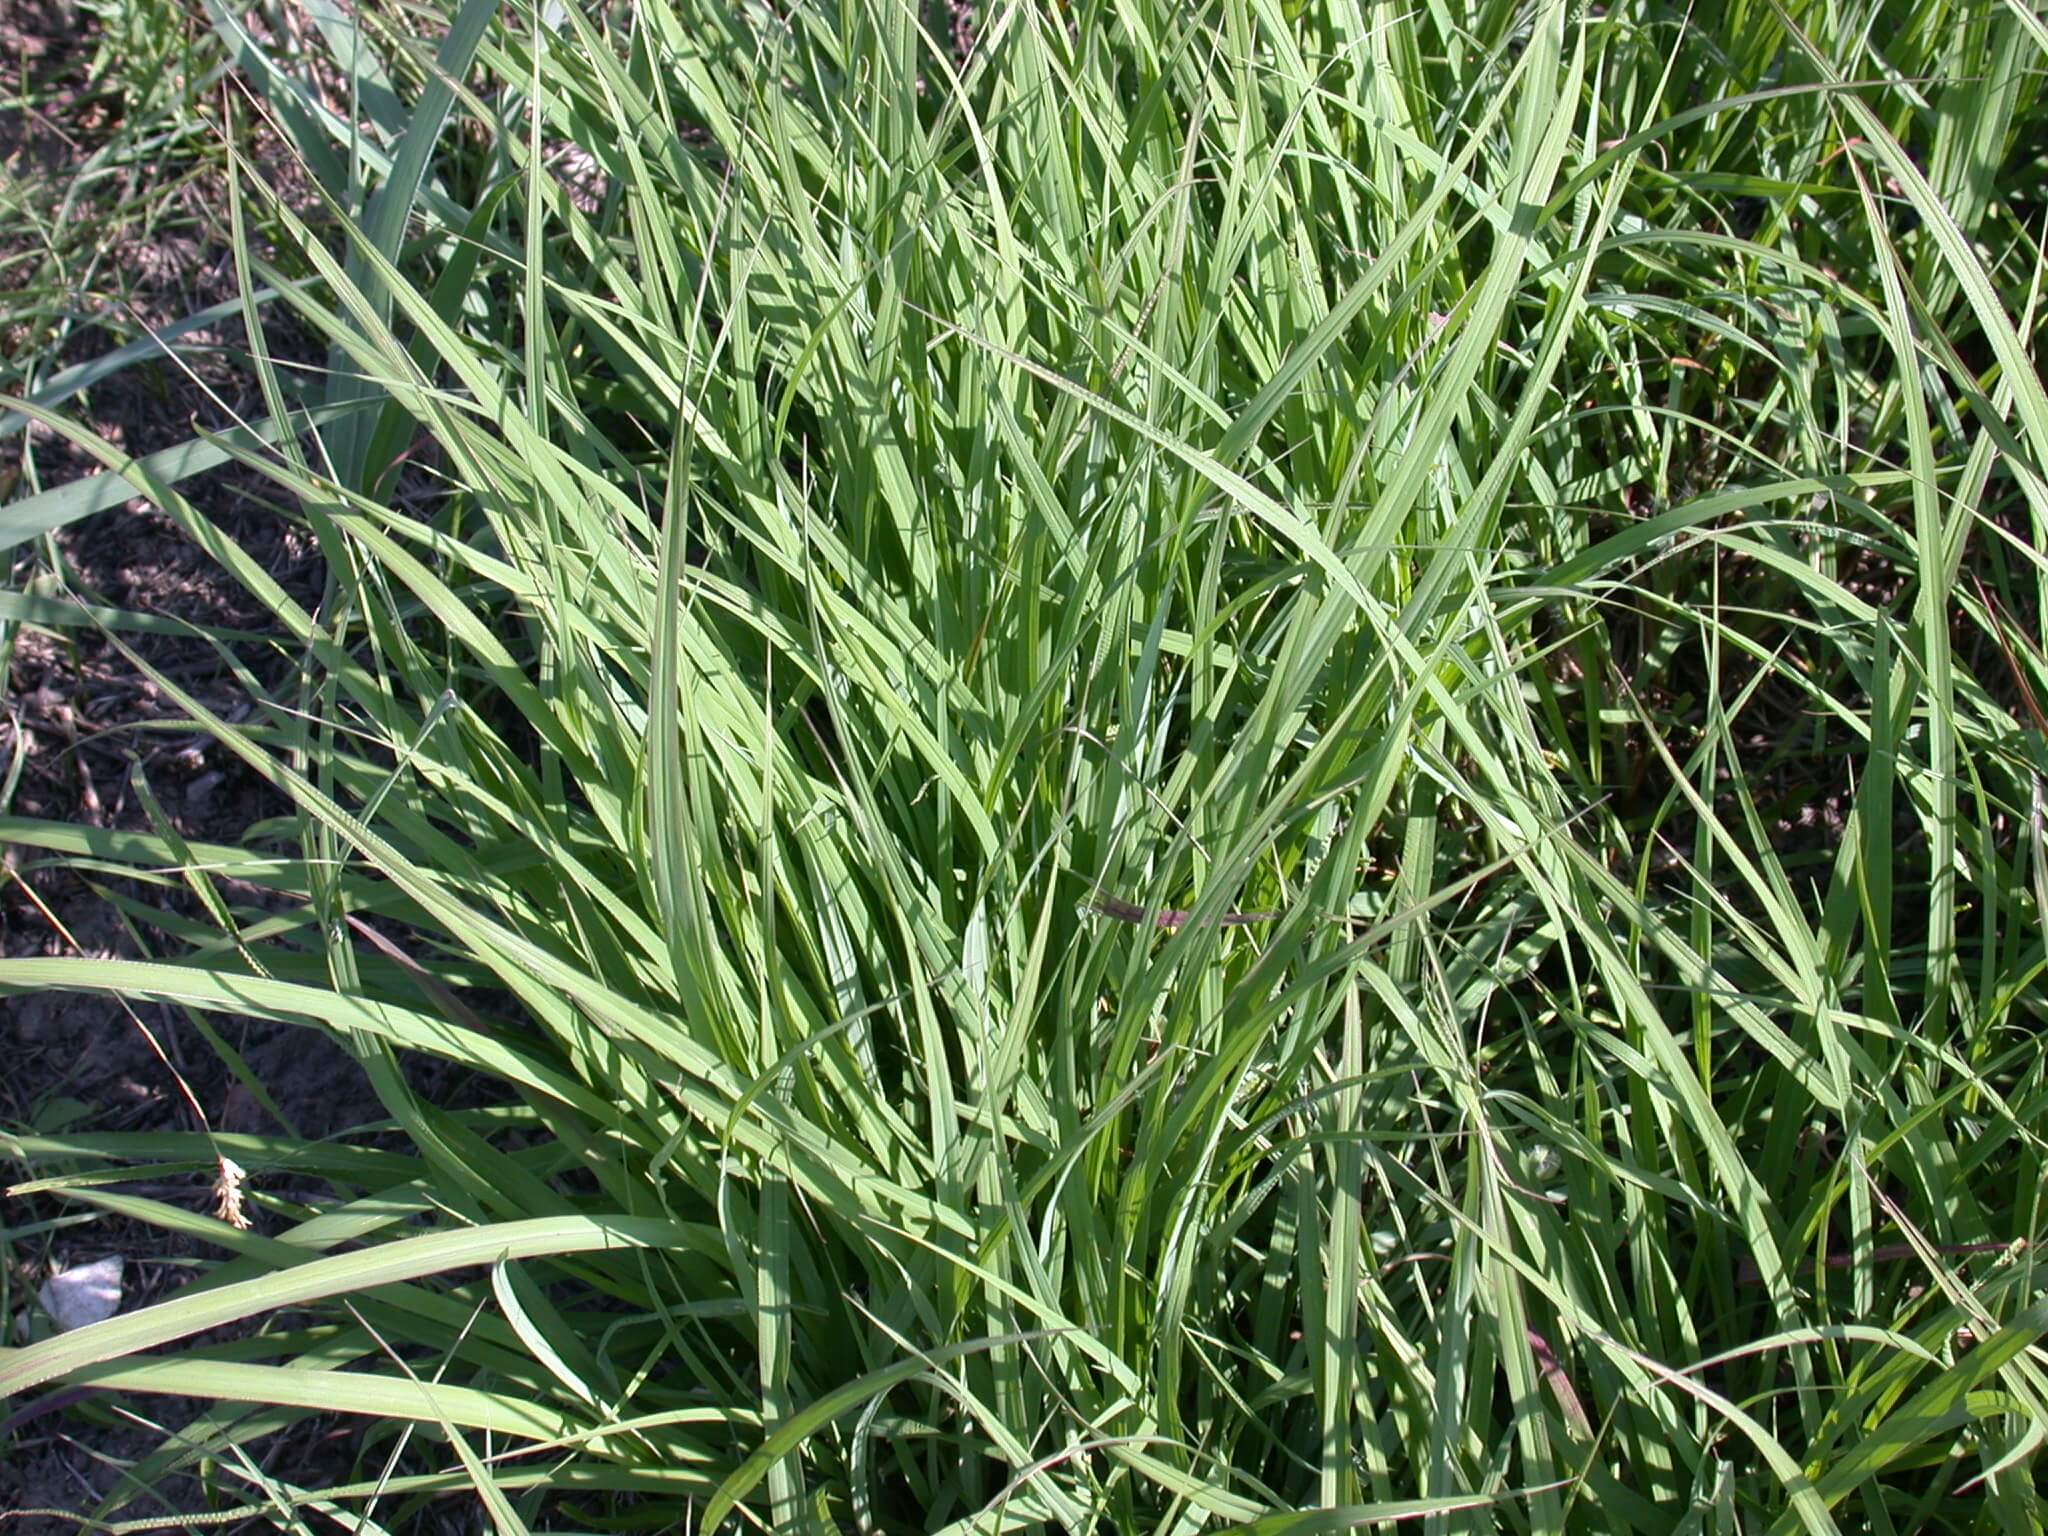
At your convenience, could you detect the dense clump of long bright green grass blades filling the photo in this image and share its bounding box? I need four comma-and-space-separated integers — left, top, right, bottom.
0, 0, 2048, 1532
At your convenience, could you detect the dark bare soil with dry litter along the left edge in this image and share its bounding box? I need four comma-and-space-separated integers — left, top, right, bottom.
0, 0, 425, 1536
